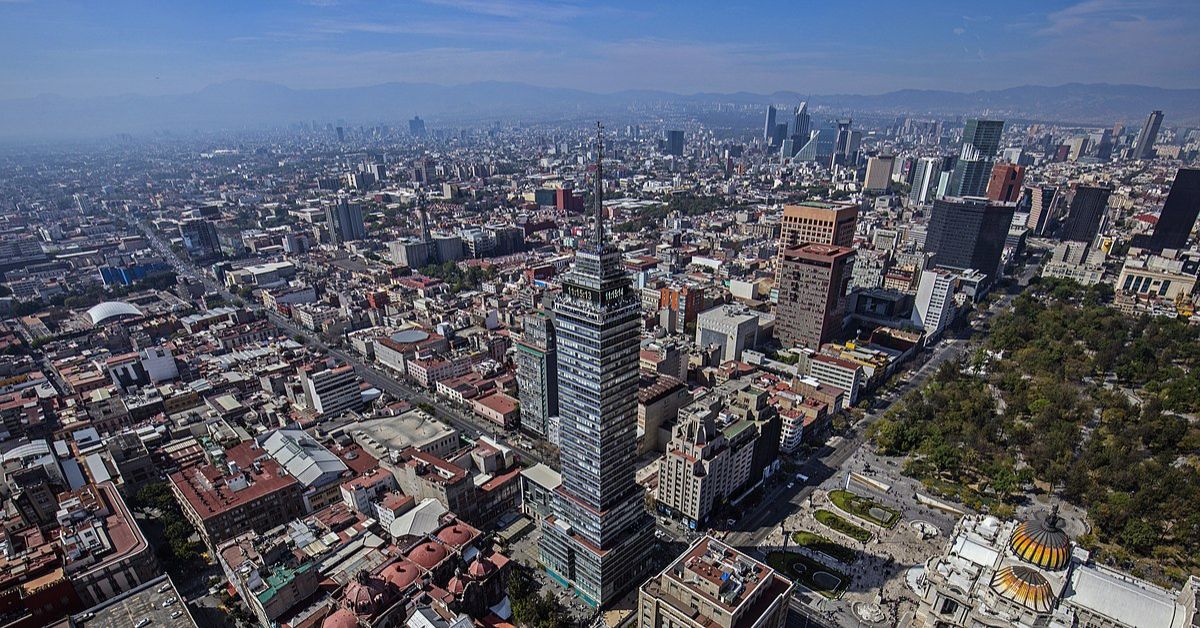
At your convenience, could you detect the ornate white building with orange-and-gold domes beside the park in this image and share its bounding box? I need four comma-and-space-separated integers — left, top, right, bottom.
910, 507, 1200, 628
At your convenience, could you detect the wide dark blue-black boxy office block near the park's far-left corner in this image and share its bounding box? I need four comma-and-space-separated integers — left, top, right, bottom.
925, 197, 1016, 283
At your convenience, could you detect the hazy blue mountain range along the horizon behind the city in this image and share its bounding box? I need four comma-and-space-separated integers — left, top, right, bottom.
0, 80, 1200, 139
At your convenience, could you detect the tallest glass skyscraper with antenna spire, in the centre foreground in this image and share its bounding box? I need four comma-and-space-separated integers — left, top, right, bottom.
539, 125, 653, 606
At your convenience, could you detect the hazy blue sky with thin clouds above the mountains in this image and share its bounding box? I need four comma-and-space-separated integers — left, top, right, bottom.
0, 0, 1200, 98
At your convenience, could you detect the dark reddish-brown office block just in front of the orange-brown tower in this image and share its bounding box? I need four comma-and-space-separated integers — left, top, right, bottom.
775, 244, 854, 349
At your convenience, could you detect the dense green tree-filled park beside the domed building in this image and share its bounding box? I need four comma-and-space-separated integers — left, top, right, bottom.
871, 280, 1200, 581
